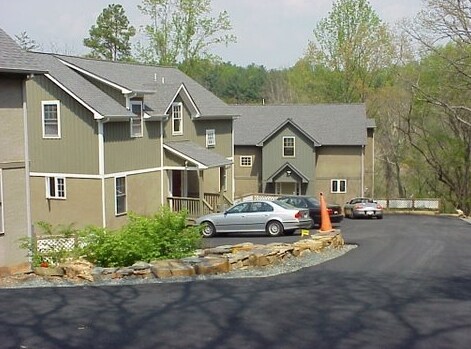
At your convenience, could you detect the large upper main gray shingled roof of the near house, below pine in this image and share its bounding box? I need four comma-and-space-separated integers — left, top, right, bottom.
58, 56, 235, 117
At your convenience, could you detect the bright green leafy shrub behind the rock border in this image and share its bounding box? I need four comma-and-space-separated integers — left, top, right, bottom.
80, 207, 201, 267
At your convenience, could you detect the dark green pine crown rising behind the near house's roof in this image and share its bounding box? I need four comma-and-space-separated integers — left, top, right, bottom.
83, 4, 136, 61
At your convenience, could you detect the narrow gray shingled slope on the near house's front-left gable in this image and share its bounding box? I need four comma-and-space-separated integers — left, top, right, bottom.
30, 53, 134, 119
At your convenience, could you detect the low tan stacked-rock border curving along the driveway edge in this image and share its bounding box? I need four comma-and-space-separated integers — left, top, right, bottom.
33, 230, 345, 283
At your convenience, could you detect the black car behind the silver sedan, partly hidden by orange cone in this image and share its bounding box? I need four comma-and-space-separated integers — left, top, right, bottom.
277, 195, 343, 226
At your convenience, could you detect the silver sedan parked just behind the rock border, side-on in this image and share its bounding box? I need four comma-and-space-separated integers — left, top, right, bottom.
196, 200, 312, 237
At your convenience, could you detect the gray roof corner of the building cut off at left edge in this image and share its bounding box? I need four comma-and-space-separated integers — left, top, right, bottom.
0, 28, 47, 73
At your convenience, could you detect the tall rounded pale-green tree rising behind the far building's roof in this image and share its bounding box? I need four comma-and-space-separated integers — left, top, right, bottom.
307, 0, 393, 103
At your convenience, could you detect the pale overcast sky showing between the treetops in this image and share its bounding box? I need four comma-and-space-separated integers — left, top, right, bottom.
0, 0, 422, 69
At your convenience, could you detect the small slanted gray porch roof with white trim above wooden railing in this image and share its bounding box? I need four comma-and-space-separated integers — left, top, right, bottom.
164, 141, 232, 169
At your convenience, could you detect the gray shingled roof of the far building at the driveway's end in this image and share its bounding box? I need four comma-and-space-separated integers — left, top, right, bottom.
234, 104, 372, 145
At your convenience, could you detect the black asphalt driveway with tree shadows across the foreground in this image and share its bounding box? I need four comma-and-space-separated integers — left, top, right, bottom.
0, 216, 471, 349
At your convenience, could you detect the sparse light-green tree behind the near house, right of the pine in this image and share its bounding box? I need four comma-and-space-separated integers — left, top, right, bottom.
138, 0, 236, 65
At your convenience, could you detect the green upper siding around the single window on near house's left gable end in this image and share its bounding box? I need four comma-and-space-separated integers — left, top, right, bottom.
27, 76, 98, 174
